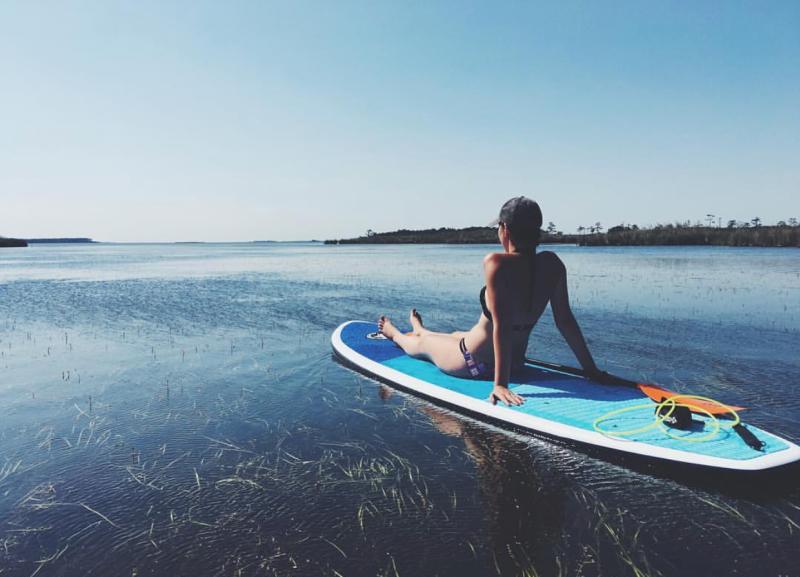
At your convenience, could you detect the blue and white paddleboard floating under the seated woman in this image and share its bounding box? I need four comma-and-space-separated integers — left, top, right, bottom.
331, 321, 800, 471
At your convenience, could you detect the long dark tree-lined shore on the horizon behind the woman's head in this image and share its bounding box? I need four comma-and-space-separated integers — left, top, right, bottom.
325, 217, 800, 247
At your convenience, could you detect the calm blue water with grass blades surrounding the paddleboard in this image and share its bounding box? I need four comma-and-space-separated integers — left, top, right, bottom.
0, 244, 800, 577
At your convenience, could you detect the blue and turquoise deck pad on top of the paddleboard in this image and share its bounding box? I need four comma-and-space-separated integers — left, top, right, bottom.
342, 323, 788, 460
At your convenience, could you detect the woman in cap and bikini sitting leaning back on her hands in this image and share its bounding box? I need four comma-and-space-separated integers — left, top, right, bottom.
379, 196, 607, 405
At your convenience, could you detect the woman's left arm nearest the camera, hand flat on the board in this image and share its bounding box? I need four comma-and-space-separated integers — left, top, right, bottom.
484, 254, 524, 405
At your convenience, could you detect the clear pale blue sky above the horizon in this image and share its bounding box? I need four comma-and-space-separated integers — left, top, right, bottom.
0, 0, 800, 242
